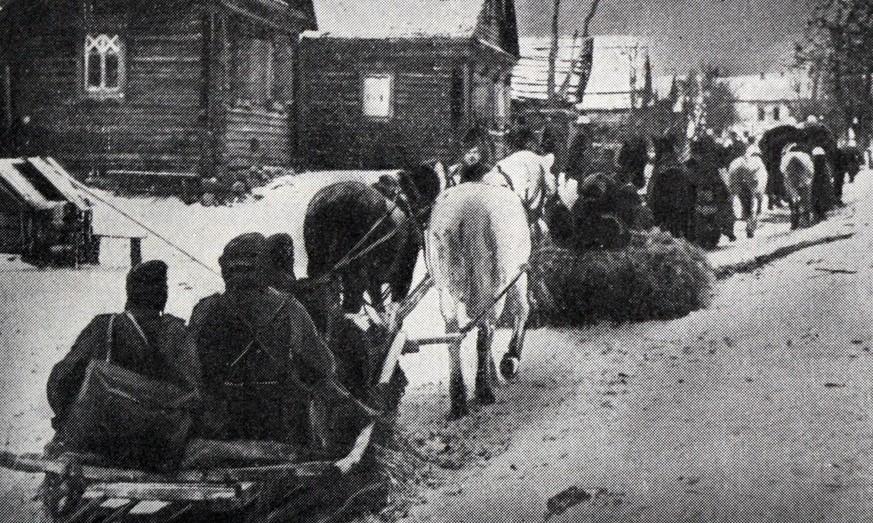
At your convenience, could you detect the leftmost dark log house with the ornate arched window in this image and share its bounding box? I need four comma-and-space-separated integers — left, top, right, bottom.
0, 0, 316, 188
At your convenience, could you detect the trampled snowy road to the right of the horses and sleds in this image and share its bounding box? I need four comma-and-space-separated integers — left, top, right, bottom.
404, 177, 873, 523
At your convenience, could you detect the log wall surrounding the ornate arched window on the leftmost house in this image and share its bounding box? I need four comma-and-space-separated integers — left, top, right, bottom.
12, 0, 203, 175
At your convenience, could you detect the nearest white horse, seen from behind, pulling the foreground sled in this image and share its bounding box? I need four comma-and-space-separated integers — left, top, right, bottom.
425, 183, 531, 418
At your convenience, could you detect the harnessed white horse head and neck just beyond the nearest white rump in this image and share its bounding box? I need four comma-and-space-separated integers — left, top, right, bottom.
482, 150, 557, 240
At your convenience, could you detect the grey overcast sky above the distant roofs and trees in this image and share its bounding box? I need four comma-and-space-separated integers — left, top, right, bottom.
515, 0, 816, 75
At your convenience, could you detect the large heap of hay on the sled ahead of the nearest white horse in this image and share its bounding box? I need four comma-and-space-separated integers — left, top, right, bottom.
531, 229, 715, 327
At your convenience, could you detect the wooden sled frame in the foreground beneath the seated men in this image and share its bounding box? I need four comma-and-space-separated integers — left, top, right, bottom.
0, 277, 432, 523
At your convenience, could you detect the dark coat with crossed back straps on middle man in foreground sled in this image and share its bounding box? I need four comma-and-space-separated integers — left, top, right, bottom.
191, 288, 374, 447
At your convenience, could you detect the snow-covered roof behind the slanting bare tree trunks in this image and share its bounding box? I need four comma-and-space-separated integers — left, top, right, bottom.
512, 35, 649, 111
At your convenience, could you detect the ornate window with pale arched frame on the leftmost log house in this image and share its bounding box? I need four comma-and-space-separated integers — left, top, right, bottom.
84, 34, 124, 97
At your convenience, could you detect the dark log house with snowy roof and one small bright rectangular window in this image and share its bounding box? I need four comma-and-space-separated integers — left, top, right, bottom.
300, 0, 519, 168
